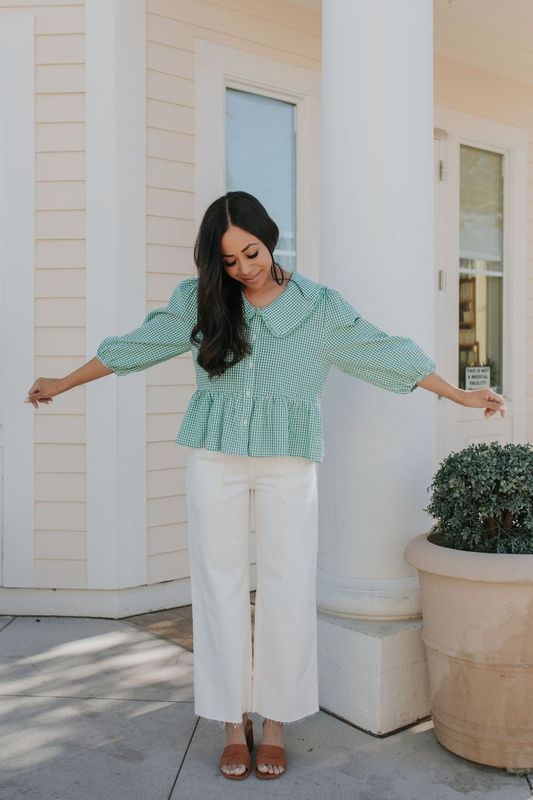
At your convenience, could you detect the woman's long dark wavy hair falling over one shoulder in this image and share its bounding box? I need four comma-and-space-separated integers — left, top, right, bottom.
191, 191, 300, 378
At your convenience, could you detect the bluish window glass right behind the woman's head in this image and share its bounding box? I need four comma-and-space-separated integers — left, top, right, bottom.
222, 89, 296, 271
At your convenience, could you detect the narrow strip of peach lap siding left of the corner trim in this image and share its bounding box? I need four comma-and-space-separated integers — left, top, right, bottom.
0, 0, 86, 588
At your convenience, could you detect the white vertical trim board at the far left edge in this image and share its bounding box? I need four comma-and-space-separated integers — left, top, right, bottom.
0, 14, 34, 587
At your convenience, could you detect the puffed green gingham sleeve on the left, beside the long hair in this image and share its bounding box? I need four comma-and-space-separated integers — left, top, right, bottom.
96, 278, 198, 375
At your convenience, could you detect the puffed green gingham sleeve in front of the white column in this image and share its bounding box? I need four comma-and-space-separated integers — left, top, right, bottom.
324, 287, 437, 394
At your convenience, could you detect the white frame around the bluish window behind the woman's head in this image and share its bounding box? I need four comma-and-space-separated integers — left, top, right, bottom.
195, 39, 320, 280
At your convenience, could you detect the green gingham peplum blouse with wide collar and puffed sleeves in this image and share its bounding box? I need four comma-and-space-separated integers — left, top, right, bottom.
96, 272, 436, 461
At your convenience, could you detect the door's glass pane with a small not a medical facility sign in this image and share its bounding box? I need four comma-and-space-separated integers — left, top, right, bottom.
459, 145, 504, 393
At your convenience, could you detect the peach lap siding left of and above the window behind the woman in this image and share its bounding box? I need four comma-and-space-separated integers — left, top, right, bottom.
146, 0, 320, 583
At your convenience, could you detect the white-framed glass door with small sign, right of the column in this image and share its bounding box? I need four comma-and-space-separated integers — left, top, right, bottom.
434, 105, 529, 459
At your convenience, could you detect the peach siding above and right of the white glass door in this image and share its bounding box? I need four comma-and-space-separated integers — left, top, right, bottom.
435, 57, 533, 443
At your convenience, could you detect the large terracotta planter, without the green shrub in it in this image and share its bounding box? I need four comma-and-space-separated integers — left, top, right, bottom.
404, 533, 533, 770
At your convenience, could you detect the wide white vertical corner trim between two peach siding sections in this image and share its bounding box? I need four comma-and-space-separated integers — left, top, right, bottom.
85, 0, 148, 589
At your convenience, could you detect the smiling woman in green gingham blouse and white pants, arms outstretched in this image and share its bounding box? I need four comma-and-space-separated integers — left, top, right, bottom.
26, 192, 506, 779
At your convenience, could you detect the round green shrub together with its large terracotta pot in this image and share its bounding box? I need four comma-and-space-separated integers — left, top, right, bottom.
404, 442, 533, 771
